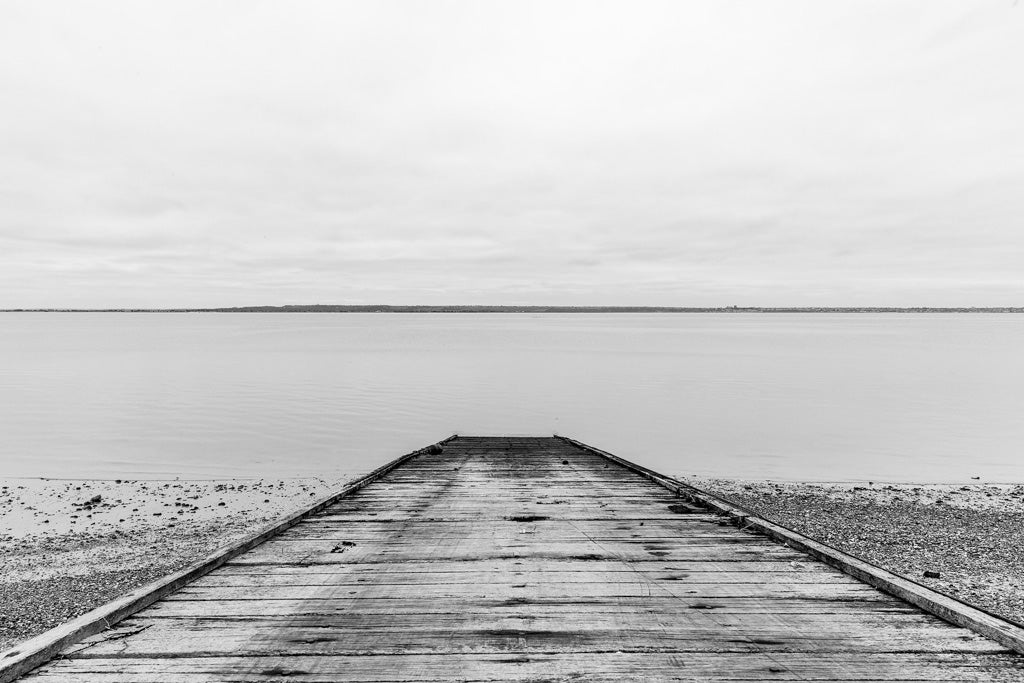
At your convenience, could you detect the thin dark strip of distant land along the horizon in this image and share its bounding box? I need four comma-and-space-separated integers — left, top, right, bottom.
0, 304, 1024, 313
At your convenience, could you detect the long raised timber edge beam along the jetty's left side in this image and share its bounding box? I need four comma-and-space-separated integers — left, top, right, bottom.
0, 434, 458, 683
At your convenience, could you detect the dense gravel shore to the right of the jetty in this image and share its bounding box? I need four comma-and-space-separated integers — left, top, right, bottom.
686, 478, 1024, 623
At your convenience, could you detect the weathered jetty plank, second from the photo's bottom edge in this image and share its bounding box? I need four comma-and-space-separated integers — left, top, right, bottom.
68, 626, 1008, 658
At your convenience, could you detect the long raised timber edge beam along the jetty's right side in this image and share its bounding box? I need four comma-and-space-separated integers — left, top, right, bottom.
555, 434, 1024, 654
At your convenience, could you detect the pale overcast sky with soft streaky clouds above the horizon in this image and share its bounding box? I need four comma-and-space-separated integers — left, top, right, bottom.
0, 0, 1024, 307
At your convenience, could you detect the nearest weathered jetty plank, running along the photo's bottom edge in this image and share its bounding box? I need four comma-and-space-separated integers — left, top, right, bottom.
22, 651, 1024, 683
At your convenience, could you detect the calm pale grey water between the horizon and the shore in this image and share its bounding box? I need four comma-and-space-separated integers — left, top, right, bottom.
0, 313, 1024, 481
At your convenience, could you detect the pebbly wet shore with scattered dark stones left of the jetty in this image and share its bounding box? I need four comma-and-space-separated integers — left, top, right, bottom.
0, 479, 340, 650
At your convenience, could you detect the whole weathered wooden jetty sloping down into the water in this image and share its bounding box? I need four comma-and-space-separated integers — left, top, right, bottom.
0, 436, 1024, 683
